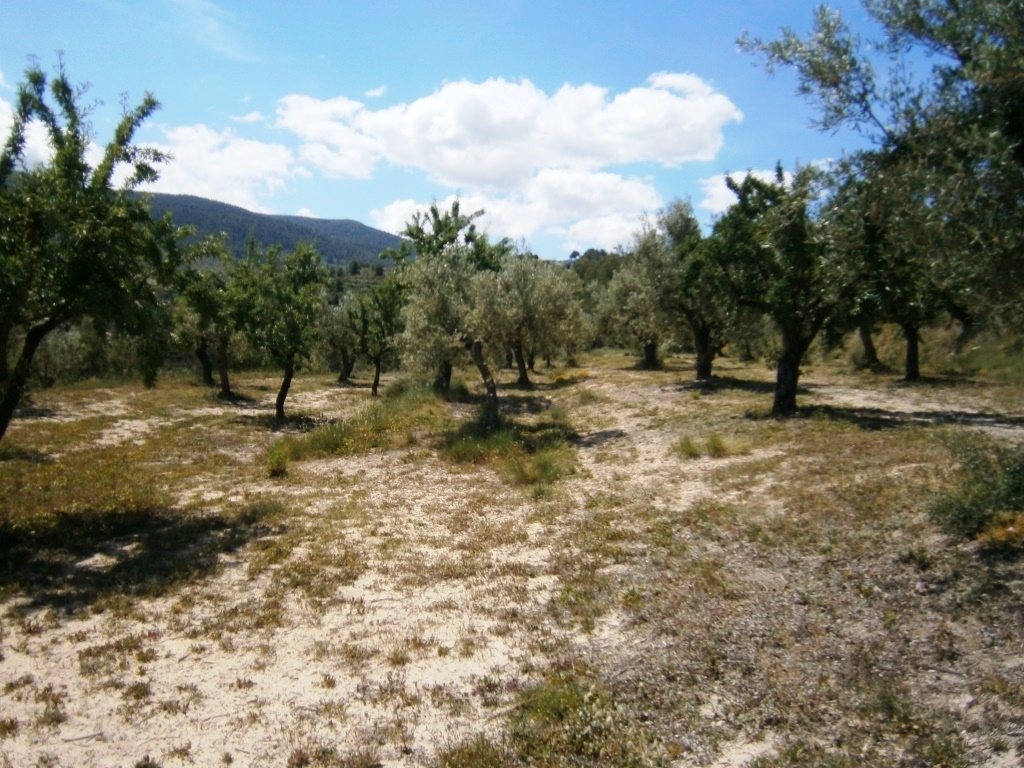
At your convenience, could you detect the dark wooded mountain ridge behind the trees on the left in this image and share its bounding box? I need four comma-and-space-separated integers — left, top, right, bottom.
146, 194, 401, 264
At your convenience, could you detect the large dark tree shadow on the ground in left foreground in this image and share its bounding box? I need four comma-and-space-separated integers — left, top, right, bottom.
0, 502, 274, 613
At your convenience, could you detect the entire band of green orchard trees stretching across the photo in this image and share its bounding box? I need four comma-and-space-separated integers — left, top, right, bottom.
0, 0, 1024, 437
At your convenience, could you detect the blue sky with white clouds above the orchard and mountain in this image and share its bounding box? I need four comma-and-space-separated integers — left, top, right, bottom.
0, 0, 869, 259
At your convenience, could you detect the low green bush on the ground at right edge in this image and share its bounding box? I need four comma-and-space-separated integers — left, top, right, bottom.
931, 432, 1024, 546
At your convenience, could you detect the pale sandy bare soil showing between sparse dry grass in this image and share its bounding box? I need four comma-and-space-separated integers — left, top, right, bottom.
0, 362, 1024, 768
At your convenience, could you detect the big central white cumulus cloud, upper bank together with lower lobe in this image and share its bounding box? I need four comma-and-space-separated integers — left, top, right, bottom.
292, 72, 742, 250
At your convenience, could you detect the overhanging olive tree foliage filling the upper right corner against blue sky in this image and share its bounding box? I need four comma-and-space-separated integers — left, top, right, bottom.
740, 0, 1024, 324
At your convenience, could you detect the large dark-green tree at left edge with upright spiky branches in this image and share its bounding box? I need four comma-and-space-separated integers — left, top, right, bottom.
0, 65, 182, 438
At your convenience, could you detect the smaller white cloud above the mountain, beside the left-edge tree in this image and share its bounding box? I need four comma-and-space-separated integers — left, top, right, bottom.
146, 124, 299, 211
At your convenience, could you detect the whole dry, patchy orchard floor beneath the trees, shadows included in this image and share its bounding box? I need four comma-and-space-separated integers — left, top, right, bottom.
0, 351, 1024, 768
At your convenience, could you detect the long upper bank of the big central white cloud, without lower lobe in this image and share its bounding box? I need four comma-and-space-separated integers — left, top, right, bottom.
278, 73, 742, 189
